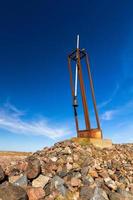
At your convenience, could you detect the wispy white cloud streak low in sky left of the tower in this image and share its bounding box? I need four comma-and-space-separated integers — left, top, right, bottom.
0, 103, 71, 139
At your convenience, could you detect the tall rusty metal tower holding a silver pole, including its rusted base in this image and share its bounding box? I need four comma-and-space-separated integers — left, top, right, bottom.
68, 35, 102, 139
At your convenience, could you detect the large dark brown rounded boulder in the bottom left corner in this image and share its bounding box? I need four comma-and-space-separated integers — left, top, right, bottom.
0, 185, 28, 200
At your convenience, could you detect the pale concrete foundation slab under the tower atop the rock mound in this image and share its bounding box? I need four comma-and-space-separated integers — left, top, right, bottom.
72, 137, 112, 148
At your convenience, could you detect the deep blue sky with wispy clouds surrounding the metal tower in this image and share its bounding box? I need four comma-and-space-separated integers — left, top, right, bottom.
0, 0, 133, 151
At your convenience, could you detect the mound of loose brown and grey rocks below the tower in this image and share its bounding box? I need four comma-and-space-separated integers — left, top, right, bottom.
0, 141, 133, 200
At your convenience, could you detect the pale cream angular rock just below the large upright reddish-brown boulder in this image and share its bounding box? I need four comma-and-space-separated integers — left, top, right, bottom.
32, 174, 50, 188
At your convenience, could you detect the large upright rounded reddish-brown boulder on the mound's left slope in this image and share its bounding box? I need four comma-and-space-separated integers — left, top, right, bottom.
26, 156, 41, 179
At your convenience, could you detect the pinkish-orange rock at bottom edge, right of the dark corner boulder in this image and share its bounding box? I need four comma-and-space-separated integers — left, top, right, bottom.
27, 187, 45, 200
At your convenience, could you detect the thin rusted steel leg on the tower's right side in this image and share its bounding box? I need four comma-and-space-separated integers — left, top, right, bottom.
85, 54, 101, 136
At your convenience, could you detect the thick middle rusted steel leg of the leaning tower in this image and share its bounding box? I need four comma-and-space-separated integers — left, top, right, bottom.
77, 49, 91, 130
